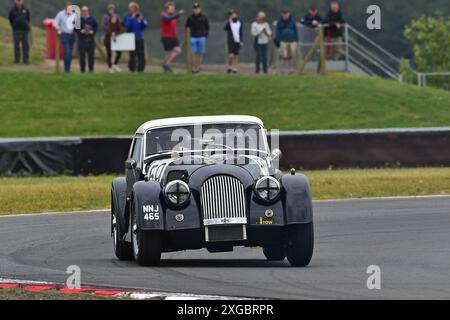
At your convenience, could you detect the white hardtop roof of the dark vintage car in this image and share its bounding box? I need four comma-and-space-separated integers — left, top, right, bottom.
136, 116, 264, 134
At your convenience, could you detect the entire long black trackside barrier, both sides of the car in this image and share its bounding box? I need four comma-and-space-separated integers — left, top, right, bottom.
0, 128, 450, 175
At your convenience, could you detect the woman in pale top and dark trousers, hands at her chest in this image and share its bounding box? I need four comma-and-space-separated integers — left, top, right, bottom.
252, 12, 272, 74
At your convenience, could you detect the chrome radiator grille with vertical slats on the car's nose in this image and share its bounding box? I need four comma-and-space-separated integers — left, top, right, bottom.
201, 176, 247, 226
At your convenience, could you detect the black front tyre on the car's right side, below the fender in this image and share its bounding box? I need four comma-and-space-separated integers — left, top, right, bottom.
287, 222, 314, 267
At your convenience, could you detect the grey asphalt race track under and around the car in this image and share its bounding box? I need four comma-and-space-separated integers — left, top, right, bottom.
0, 197, 450, 299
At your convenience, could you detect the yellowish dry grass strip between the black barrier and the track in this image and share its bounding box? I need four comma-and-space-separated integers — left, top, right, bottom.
0, 168, 450, 215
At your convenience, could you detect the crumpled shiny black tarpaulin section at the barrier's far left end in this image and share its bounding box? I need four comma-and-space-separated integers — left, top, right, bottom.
0, 138, 82, 175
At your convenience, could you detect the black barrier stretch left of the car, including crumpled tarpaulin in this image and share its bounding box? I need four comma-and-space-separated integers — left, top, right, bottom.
0, 137, 131, 176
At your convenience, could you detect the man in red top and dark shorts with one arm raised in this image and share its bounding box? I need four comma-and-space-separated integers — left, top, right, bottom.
161, 2, 184, 72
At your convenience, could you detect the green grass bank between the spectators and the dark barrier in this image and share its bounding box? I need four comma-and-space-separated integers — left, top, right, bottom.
0, 73, 450, 137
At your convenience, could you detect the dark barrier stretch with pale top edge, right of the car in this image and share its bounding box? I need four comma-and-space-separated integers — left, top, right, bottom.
269, 127, 450, 170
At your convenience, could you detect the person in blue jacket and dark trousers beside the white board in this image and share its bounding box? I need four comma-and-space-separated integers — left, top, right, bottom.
125, 2, 148, 72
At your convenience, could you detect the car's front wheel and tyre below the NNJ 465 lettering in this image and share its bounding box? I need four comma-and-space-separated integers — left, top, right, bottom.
131, 199, 162, 267
